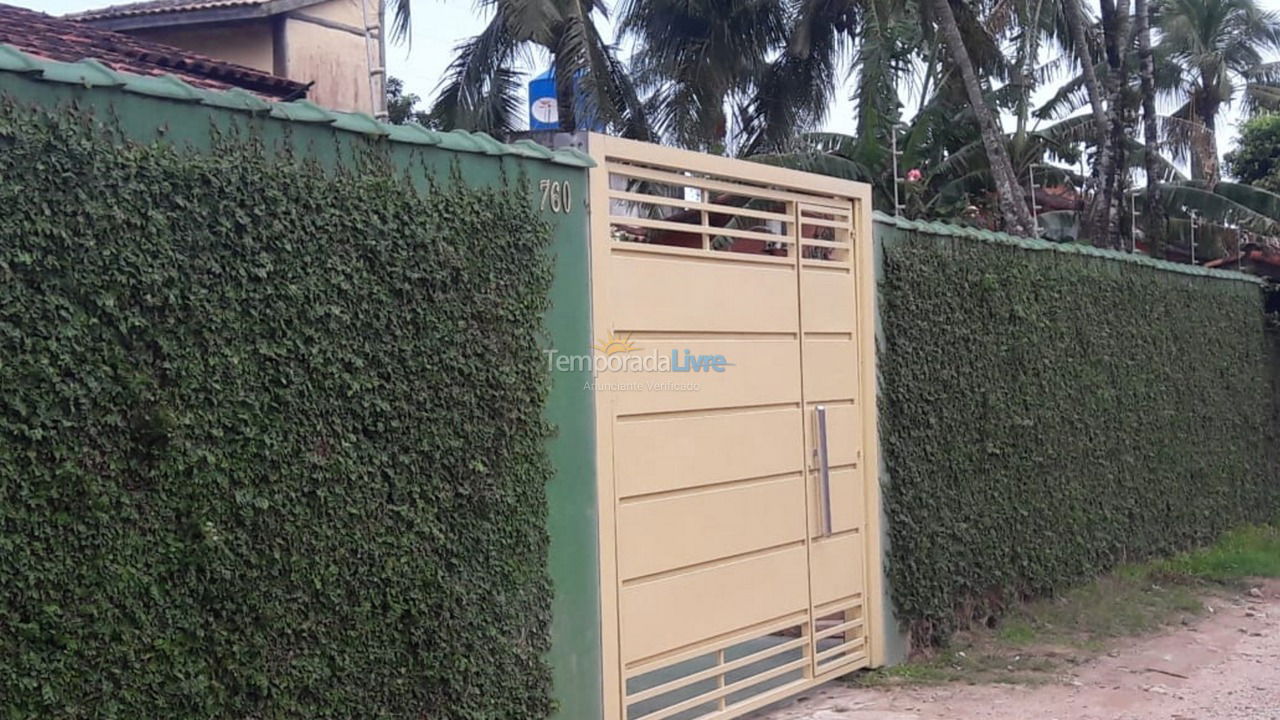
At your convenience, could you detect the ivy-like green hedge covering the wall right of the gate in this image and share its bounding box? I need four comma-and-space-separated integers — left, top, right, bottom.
881, 229, 1280, 643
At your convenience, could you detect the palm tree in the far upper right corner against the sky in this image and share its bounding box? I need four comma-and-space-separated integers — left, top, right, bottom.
1156, 0, 1280, 187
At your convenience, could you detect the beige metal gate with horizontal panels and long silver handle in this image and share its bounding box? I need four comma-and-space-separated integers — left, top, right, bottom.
589, 135, 882, 720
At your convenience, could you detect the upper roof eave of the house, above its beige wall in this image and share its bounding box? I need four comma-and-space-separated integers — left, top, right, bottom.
65, 0, 324, 29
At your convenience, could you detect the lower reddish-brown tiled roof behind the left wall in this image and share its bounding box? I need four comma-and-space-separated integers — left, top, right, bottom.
0, 0, 308, 100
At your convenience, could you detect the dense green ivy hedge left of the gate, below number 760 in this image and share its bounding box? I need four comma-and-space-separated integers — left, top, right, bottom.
0, 100, 552, 720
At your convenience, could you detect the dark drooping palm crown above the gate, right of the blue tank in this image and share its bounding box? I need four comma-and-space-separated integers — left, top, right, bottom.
621, 0, 920, 155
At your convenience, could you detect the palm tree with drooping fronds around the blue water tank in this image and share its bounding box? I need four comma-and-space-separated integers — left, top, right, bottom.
388, 0, 650, 138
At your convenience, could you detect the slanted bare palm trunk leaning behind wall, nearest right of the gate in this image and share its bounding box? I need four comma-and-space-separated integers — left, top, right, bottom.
932, 0, 1036, 236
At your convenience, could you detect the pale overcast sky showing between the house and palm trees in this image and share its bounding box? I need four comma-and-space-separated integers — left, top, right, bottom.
17, 0, 1280, 151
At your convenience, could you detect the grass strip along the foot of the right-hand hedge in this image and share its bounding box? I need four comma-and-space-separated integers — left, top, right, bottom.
849, 521, 1280, 687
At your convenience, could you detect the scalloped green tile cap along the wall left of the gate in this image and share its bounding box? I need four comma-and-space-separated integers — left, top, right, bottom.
0, 44, 595, 168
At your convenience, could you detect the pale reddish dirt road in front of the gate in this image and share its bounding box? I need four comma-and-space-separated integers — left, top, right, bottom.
751, 582, 1280, 720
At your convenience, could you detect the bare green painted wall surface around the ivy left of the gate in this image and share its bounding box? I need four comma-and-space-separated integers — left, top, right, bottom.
0, 63, 602, 720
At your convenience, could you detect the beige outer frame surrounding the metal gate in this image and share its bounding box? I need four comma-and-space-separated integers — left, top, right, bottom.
582, 132, 886, 720
